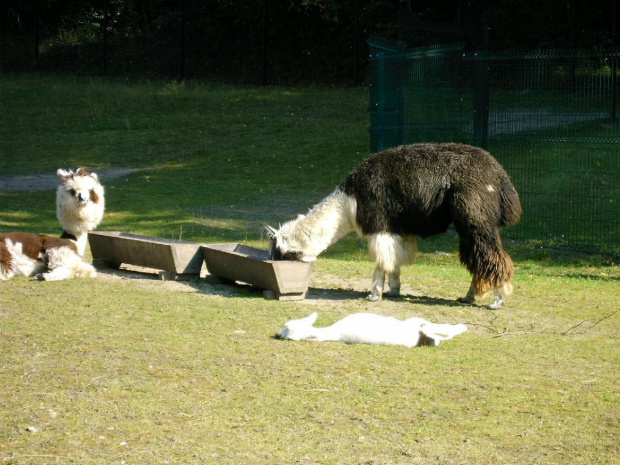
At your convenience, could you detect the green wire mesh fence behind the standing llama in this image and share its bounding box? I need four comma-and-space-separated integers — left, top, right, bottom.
370, 39, 620, 252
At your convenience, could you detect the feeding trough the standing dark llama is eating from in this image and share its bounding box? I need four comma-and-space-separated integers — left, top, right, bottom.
201, 243, 314, 300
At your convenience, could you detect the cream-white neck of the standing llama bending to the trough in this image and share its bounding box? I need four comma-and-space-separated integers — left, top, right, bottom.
283, 189, 357, 261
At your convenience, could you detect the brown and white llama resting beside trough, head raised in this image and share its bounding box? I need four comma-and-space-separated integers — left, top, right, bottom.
0, 168, 105, 281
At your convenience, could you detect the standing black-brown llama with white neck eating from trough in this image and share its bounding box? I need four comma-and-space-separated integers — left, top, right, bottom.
265, 144, 522, 309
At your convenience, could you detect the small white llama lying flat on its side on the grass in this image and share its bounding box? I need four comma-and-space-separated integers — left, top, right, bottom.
276, 312, 467, 347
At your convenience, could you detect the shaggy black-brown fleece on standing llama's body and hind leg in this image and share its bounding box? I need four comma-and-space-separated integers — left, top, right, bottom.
340, 144, 522, 295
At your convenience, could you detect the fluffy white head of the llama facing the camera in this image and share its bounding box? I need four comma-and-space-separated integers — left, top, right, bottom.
56, 168, 105, 236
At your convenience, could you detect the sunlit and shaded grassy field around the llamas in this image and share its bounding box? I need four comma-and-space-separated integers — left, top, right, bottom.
0, 76, 620, 465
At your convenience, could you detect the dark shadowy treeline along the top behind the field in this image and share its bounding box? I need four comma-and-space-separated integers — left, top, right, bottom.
0, 0, 618, 84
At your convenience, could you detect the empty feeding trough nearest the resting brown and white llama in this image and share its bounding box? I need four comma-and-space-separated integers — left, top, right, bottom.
88, 231, 203, 280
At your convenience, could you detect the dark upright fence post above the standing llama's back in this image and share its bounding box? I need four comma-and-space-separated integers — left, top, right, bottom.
474, 26, 489, 150
